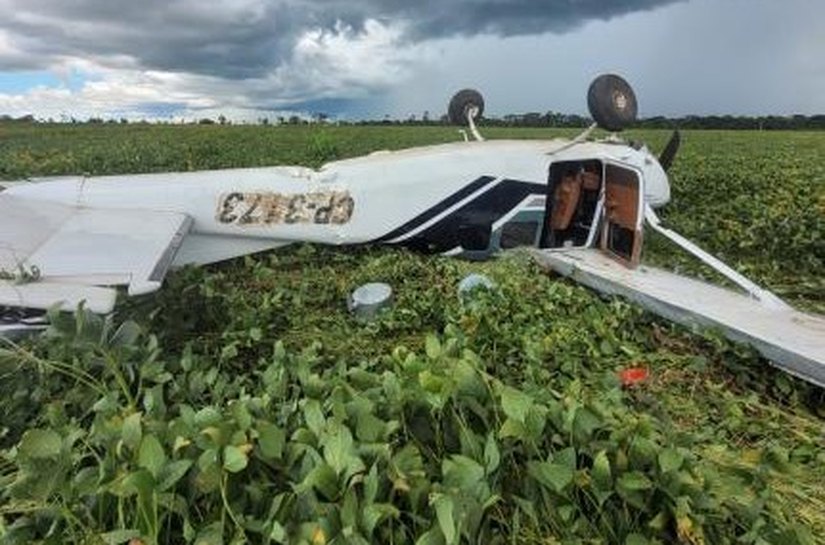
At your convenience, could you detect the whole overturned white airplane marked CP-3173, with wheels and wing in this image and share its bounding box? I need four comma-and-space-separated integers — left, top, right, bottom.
0, 75, 825, 386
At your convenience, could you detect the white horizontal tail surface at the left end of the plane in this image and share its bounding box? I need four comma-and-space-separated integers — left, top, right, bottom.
0, 194, 192, 313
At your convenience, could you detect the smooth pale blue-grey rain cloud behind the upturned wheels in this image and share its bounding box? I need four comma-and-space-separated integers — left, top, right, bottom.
390, 0, 825, 117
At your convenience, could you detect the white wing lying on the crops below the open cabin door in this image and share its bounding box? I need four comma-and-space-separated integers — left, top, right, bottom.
532, 249, 825, 387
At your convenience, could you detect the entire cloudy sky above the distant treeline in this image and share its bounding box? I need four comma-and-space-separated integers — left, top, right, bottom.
0, 0, 825, 120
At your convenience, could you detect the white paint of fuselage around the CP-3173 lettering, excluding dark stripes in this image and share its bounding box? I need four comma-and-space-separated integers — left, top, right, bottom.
0, 140, 558, 244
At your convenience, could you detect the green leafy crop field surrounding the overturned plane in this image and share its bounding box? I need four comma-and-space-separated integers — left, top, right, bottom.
0, 124, 825, 545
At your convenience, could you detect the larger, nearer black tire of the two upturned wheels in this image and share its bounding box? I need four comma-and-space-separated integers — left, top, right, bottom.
587, 74, 639, 132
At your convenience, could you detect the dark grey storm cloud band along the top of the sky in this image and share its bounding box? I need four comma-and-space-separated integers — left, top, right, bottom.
0, 0, 678, 79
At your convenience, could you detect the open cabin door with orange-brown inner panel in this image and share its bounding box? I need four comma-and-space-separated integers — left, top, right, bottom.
599, 163, 644, 267
